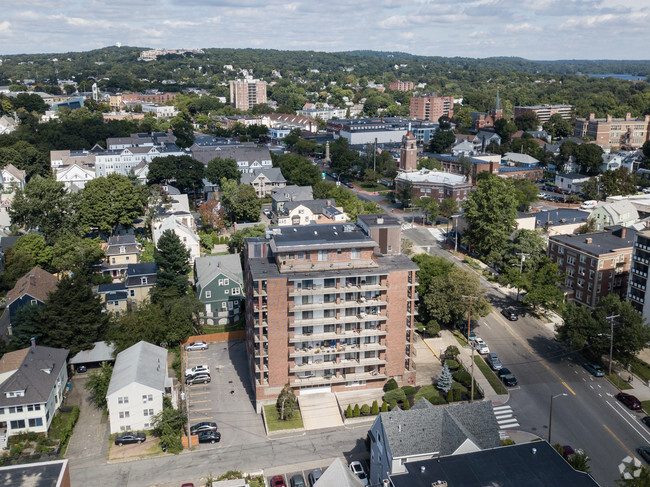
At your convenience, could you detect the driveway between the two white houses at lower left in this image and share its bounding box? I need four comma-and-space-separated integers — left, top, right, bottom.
65, 374, 108, 466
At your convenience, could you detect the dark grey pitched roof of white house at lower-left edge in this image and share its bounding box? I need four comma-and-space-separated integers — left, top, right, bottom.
0, 345, 68, 406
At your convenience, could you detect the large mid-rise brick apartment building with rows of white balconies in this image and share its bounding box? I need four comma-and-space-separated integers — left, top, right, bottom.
245, 215, 417, 411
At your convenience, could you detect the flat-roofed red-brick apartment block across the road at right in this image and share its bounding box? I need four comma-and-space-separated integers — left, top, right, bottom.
548, 226, 632, 308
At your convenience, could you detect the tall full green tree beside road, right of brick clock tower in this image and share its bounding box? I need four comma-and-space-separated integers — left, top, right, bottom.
465, 174, 517, 259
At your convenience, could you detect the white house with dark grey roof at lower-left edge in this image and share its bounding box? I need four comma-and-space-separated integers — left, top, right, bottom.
0, 346, 68, 436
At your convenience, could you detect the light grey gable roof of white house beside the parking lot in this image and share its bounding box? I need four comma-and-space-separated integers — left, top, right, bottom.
106, 341, 167, 397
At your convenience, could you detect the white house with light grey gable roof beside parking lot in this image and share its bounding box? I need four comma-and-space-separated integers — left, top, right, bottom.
106, 341, 175, 434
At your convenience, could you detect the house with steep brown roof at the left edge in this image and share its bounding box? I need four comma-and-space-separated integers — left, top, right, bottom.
0, 267, 58, 337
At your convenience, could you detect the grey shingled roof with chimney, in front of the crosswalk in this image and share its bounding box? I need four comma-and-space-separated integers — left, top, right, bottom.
376, 399, 501, 458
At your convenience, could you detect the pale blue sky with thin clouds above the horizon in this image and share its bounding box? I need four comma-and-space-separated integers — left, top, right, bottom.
0, 0, 650, 60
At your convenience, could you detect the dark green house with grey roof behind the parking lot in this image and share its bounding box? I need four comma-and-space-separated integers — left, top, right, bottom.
194, 254, 244, 325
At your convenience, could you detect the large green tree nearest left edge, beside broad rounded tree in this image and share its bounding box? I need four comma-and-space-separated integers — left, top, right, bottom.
9, 176, 77, 243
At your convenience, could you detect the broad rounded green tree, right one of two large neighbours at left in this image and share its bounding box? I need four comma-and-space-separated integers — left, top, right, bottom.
78, 174, 146, 234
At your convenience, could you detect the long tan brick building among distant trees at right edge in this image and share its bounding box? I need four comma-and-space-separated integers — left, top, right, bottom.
573, 113, 650, 149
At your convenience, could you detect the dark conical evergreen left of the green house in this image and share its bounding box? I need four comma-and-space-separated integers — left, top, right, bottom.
152, 230, 191, 302
